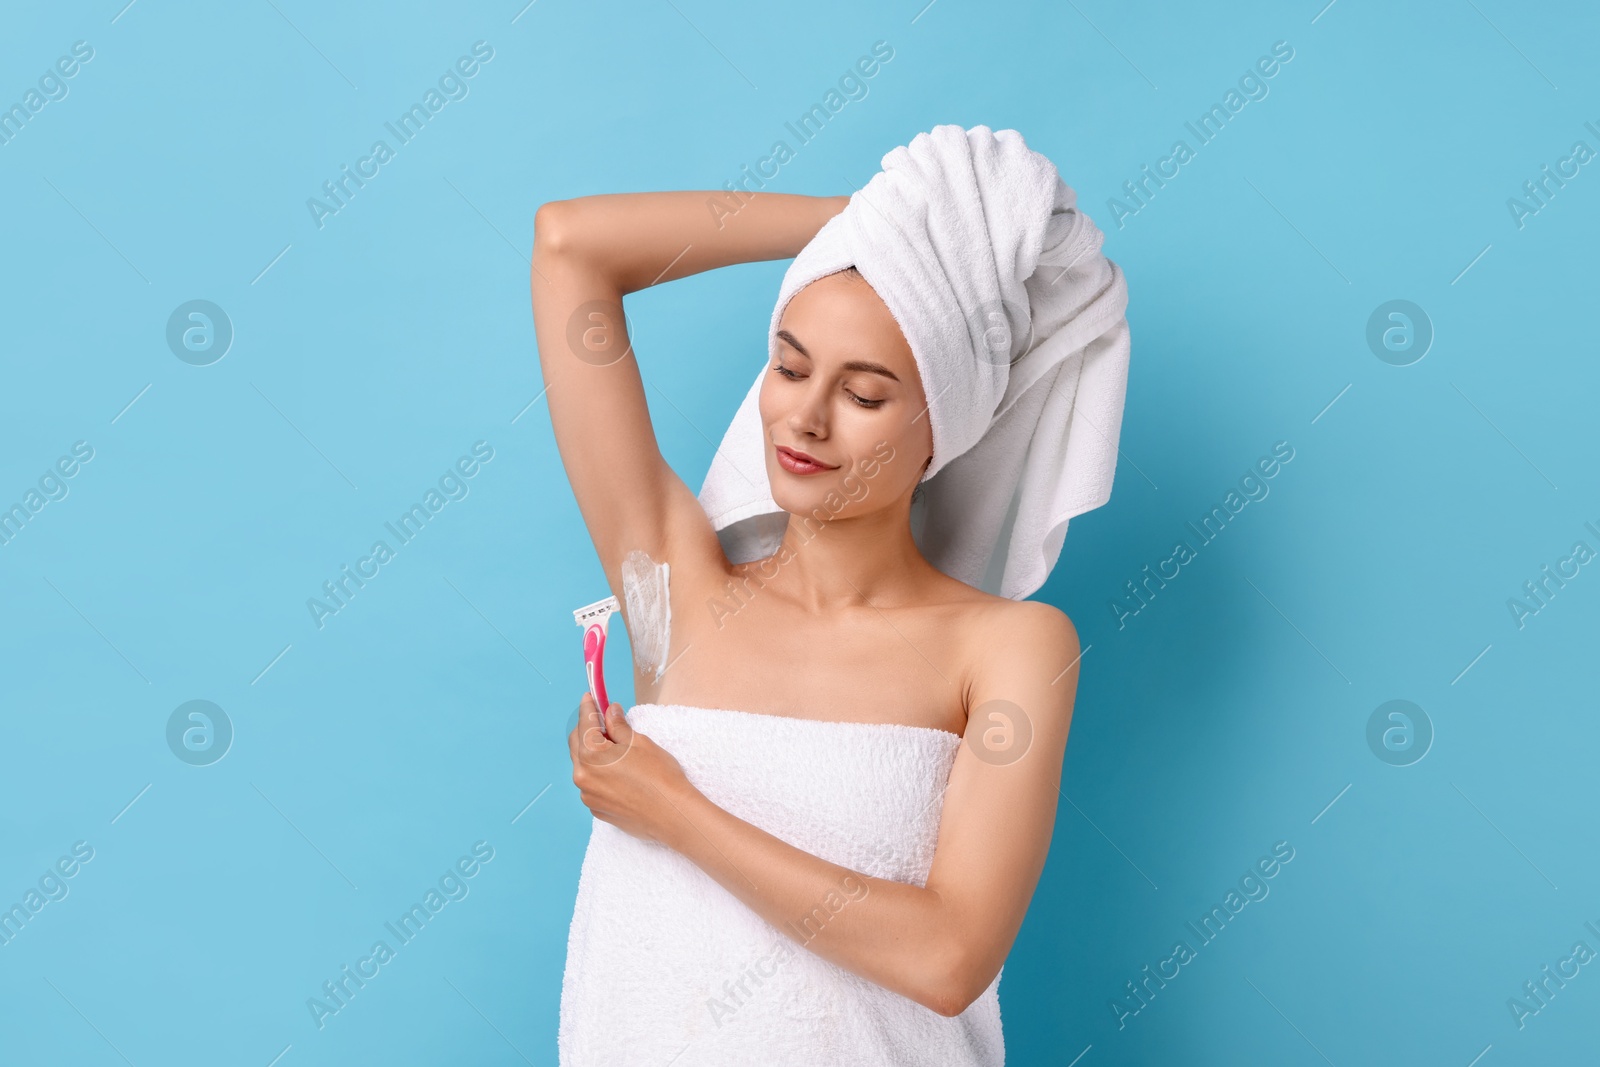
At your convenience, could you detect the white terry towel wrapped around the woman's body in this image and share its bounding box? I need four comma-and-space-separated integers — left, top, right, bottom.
558, 704, 1005, 1067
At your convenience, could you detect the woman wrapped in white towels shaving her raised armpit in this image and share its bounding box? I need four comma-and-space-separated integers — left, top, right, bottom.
531, 126, 1126, 1067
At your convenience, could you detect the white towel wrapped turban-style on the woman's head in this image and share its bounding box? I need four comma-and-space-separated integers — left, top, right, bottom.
699, 125, 1130, 600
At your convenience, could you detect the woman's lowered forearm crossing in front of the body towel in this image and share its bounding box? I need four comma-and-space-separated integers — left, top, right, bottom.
666, 787, 966, 1014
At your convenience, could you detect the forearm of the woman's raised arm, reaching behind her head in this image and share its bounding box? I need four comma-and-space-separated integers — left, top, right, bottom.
534, 190, 850, 293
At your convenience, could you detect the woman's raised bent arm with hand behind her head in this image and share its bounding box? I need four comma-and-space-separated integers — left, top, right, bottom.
530, 192, 850, 592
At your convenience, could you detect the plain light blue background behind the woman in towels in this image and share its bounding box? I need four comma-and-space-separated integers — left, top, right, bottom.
0, 0, 1600, 1067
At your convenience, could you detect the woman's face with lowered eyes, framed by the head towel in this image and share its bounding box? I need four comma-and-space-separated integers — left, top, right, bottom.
758, 272, 933, 518
